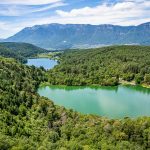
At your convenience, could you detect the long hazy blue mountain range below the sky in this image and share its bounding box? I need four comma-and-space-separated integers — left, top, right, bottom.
4, 22, 150, 49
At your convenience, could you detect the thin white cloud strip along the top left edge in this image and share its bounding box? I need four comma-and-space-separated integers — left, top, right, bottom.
0, 0, 62, 5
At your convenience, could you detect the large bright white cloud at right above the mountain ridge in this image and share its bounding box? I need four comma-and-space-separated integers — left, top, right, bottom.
56, 0, 150, 25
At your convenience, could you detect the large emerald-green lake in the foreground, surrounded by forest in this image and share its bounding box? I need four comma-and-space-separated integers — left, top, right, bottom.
38, 86, 150, 118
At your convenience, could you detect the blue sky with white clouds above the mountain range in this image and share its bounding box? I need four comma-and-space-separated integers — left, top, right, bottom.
0, 0, 150, 38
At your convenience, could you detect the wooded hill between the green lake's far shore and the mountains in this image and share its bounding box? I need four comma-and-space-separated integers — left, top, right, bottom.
47, 46, 150, 85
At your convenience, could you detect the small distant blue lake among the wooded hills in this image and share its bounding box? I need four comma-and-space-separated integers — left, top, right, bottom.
26, 58, 57, 70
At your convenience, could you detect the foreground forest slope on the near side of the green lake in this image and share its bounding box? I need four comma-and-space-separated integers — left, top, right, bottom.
0, 52, 150, 150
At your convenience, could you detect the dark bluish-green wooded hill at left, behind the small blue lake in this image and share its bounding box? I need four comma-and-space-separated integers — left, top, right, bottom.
0, 42, 47, 63
